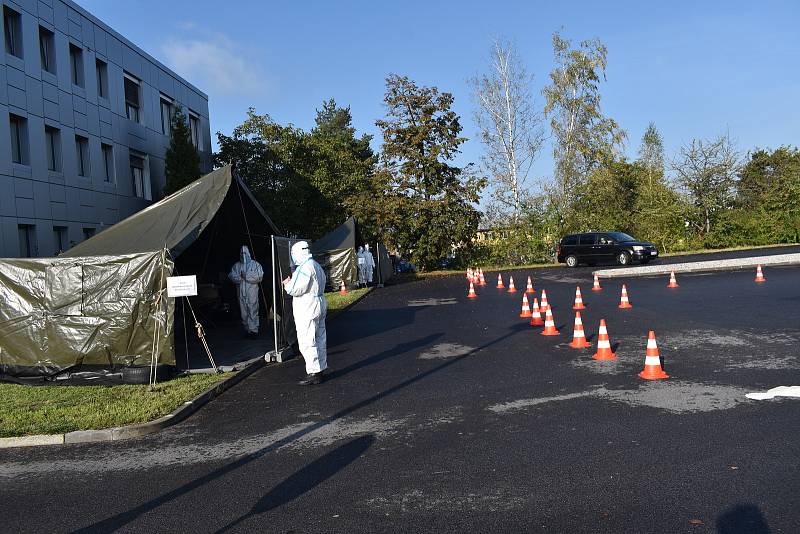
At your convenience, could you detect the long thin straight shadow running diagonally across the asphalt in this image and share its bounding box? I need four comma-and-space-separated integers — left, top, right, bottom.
74, 325, 526, 534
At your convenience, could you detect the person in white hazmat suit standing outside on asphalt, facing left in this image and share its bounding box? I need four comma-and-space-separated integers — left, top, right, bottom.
283, 241, 328, 386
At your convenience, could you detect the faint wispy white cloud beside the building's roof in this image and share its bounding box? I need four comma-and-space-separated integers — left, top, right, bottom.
161, 28, 268, 97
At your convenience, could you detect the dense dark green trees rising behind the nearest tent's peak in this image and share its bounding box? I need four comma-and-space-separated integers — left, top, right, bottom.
216, 107, 375, 239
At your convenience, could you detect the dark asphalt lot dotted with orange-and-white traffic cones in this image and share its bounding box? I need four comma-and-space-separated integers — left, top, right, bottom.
0, 251, 800, 534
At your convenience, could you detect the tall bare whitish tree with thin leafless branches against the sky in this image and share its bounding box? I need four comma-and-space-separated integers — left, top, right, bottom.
470, 39, 544, 223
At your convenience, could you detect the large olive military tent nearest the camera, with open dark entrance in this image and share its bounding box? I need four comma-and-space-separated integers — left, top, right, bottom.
0, 165, 294, 377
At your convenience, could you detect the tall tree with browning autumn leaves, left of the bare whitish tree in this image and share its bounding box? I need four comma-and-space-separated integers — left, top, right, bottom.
361, 74, 485, 269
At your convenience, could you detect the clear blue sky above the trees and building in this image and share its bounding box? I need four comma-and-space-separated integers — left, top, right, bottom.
78, 0, 800, 182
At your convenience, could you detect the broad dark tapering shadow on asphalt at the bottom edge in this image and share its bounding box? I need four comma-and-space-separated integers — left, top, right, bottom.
212, 436, 375, 533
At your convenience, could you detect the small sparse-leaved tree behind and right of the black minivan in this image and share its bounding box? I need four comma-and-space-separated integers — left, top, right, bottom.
672, 135, 740, 235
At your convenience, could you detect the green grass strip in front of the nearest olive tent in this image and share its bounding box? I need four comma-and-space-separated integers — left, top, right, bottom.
0, 373, 233, 437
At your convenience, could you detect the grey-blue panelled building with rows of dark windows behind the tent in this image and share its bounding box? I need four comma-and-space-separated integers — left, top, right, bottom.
0, 0, 211, 257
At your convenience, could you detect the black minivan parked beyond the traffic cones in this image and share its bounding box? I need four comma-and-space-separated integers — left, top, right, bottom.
556, 232, 658, 267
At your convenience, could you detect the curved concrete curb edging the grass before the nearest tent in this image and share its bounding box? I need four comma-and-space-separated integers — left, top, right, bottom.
0, 358, 265, 449
